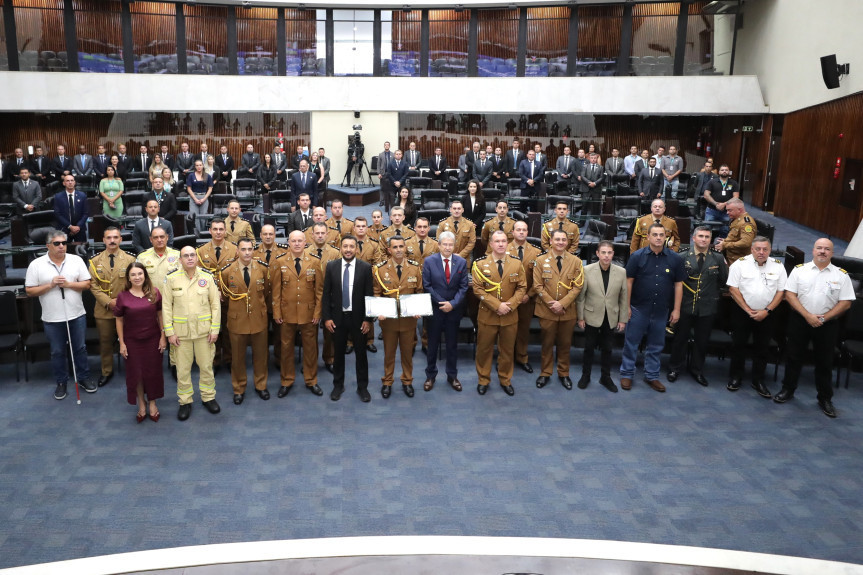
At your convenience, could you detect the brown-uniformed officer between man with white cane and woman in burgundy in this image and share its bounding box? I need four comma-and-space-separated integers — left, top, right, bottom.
90, 226, 136, 387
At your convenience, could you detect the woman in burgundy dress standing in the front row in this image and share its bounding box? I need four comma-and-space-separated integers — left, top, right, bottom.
114, 262, 167, 423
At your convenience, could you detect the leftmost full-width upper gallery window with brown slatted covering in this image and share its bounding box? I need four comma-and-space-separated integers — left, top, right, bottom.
13, 0, 69, 72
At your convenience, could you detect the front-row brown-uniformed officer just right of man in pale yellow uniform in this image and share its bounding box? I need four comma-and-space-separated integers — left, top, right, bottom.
219, 238, 270, 405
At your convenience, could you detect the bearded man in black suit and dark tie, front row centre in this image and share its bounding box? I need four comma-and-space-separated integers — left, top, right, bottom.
318, 236, 374, 403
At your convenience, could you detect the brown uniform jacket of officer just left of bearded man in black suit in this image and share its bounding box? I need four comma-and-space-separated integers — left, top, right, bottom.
270, 251, 324, 325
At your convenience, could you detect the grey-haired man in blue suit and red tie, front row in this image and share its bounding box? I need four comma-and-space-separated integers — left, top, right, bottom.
423, 232, 469, 391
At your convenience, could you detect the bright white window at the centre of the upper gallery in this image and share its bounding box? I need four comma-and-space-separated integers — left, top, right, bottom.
333, 10, 374, 76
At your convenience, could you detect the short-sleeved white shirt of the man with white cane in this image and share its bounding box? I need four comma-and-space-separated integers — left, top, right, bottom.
24, 254, 90, 322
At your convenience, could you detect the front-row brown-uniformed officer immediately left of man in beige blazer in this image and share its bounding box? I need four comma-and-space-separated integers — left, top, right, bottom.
533, 230, 584, 390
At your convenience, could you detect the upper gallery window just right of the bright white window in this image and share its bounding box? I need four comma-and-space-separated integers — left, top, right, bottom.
381, 10, 422, 76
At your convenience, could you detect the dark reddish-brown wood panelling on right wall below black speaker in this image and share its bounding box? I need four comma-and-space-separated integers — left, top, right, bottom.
774, 94, 863, 240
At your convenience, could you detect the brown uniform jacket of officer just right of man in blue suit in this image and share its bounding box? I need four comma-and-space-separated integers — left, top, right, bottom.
471, 254, 527, 325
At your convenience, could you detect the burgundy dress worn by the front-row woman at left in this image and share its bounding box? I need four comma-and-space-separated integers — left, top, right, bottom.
114, 288, 165, 405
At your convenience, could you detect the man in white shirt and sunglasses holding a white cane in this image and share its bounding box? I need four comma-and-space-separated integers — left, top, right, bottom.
24, 230, 98, 403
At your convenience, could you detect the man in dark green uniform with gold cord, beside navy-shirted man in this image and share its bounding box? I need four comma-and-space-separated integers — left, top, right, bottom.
668, 227, 728, 387
